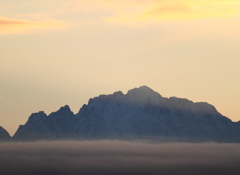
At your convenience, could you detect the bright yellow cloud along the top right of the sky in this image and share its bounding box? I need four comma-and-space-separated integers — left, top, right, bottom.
108, 0, 240, 23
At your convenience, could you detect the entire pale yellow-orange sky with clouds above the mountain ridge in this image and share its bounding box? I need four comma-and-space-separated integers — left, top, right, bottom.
0, 0, 240, 135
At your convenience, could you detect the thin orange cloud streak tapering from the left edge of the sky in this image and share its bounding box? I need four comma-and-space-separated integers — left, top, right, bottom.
0, 17, 66, 35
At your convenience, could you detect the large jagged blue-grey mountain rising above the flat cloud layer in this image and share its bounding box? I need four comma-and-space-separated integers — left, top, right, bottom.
13, 86, 240, 142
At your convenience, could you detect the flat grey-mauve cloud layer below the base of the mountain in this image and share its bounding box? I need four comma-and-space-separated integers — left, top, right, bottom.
0, 141, 240, 175
